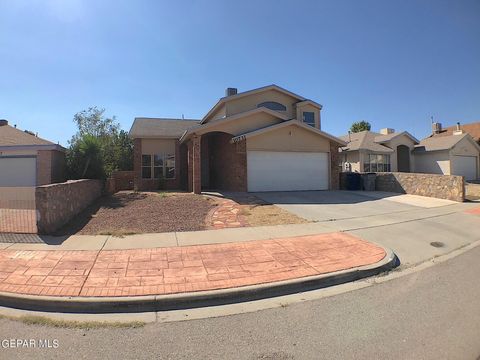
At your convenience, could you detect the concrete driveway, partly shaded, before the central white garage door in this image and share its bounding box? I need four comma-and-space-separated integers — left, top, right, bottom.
255, 191, 456, 221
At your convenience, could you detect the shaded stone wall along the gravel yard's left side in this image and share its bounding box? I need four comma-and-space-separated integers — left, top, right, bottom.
35, 179, 103, 234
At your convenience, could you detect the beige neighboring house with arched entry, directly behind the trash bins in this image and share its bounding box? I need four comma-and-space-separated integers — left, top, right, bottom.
340, 128, 418, 172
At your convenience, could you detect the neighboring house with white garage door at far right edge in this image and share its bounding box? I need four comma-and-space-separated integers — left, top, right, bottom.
414, 123, 480, 180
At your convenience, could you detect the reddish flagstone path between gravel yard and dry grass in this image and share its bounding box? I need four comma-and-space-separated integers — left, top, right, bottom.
206, 199, 248, 229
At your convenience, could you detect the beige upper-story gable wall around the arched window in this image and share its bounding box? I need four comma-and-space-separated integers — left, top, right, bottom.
225, 90, 298, 118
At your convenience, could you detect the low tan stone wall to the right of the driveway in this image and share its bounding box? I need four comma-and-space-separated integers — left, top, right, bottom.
375, 172, 465, 202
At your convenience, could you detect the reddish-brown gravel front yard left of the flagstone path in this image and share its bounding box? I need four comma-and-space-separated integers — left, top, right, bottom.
56, 191, 216, 237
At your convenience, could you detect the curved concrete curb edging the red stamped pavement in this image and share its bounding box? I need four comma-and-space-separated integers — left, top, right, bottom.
0, 248, 399, 314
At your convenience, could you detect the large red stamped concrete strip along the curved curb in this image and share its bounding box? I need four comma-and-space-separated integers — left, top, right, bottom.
0, 233, 386, 296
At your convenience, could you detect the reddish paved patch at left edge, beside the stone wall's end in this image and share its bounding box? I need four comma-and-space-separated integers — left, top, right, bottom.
0, 209, 37, 234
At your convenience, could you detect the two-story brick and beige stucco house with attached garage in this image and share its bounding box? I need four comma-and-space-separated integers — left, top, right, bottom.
130, 85, 345, 193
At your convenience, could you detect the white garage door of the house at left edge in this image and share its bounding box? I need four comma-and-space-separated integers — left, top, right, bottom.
0, 156, 37, 187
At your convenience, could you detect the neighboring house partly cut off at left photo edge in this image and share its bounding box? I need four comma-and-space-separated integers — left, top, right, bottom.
0, 120, 65, 187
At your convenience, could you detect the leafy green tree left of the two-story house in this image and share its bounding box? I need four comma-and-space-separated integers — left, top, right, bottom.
67, 107, 133, 179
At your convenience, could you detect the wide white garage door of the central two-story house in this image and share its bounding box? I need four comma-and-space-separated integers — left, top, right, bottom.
247, 151, 329, 191
